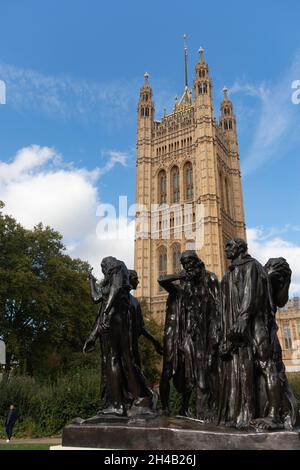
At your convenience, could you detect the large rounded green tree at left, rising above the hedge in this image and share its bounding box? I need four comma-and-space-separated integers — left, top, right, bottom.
0, 204, 95, 374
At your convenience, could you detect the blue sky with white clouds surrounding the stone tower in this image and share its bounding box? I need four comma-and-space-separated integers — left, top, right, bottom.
0, 0, 300, 292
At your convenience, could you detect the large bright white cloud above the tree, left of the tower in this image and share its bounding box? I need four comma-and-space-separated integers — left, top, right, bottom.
0, 145, 133, 274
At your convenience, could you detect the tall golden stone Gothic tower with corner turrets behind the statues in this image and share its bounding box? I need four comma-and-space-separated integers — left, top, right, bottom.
135, 48, 246, 321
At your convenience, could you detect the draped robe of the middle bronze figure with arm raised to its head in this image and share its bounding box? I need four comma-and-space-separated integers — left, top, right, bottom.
160, 271, 219, 416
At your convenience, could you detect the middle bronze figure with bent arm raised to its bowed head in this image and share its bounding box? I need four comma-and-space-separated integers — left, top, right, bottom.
158, 250, 218, 419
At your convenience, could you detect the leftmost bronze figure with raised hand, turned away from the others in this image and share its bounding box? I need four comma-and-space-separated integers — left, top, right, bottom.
84, 256, 153, 416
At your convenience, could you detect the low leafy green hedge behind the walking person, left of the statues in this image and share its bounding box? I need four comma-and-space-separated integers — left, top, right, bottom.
0, 367, 101, 437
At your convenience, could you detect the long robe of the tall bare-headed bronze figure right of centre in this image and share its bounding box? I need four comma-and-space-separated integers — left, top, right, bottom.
218, 255, 271, 428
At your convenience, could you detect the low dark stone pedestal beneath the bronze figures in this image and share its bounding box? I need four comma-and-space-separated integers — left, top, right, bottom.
62, 417, 300, 450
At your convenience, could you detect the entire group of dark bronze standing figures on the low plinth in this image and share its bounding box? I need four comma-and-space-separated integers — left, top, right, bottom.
84, 238, 297, 431
